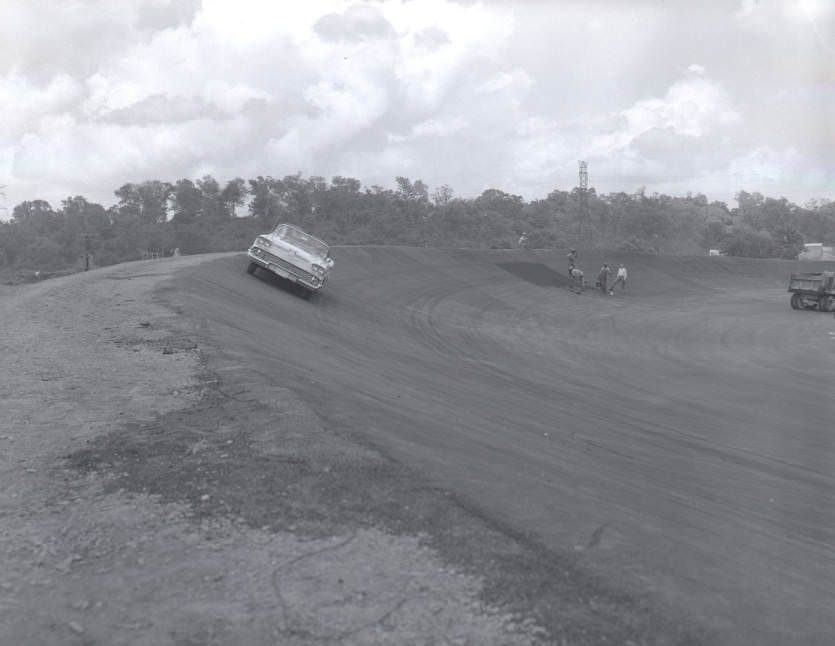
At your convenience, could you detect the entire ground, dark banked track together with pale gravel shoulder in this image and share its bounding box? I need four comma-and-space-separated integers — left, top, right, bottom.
0, 248, 835, 644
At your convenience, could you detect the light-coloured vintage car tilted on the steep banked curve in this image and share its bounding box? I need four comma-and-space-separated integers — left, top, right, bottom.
247, 224, 333, 298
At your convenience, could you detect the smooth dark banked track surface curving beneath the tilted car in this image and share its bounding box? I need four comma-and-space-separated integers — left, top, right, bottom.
166, 247, 835, 644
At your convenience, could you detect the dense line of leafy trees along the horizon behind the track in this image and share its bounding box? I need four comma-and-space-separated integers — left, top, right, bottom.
0, 173, 835, 273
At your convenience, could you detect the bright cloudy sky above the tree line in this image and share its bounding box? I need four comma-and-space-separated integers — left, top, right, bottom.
0, 0, 835, 217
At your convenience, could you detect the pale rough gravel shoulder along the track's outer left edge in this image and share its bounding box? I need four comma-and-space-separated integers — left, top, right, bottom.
0, 256, 559, 646
